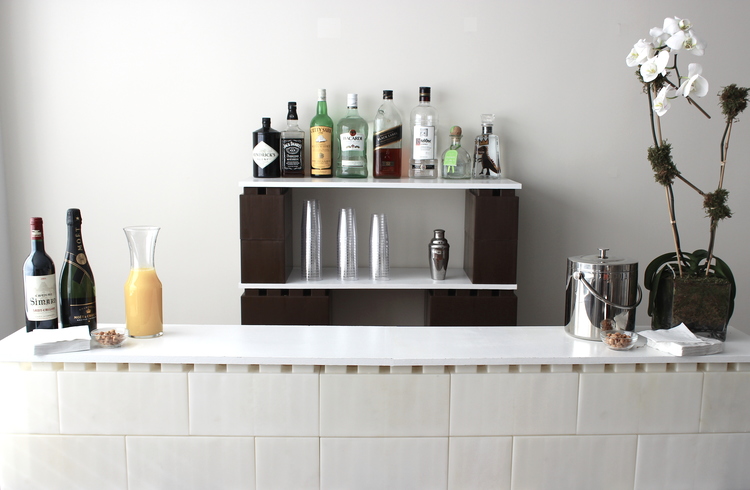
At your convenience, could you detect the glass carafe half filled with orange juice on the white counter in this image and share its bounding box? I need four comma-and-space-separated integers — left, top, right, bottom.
123, 226, 164, 339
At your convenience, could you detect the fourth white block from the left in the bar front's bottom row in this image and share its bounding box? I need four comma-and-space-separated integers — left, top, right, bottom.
320, 437, 448, 490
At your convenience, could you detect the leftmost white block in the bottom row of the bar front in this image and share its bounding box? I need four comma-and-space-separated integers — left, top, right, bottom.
0, 435, 127, 490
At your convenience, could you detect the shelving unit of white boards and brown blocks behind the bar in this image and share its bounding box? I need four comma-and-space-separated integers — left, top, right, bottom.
239, 177, 521, 325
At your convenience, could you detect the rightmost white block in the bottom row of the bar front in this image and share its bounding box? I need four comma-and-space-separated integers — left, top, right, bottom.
635, 434, 750, 490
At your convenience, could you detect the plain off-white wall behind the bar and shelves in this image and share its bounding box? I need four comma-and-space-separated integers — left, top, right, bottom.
0, 0, 750, 334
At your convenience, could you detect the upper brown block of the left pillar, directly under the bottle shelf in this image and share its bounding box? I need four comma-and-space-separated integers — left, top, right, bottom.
240, 187, 292, 240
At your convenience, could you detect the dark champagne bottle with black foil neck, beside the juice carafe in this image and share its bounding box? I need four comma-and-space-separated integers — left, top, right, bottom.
60, 209, 96, 332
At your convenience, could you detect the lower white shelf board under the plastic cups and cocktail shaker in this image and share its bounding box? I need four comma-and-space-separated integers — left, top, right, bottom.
240, 267, 517, 291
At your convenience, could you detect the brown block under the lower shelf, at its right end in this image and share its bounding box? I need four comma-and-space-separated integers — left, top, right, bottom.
425, 289, 518, 326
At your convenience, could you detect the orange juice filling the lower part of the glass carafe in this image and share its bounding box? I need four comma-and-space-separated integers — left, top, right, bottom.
125, 268, 164, 337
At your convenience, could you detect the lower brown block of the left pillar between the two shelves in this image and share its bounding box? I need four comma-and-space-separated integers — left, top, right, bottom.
240, 238, 292, 283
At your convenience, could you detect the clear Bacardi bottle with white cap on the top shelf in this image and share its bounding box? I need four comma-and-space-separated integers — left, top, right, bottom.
336, 94, 367, 177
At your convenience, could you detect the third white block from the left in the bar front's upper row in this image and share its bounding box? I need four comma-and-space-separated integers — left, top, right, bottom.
189, 373, 319, 436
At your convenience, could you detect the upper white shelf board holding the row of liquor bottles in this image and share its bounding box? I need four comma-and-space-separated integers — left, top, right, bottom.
240, 176, 521, 189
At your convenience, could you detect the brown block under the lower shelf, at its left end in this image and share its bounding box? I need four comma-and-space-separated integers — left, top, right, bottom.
240, 289, 331, 325
